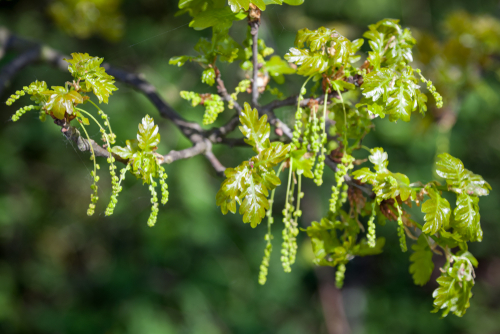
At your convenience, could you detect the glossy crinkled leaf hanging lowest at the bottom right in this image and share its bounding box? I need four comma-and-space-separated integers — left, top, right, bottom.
432, 260, 474, 317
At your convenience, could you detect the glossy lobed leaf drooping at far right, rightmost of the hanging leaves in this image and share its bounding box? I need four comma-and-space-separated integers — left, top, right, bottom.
453, 194, 483, 241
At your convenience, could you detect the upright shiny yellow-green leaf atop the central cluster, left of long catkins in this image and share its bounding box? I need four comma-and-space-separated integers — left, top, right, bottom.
240, 102, 271, 152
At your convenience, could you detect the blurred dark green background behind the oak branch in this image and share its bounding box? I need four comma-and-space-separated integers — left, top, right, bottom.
0, 0, 500, 334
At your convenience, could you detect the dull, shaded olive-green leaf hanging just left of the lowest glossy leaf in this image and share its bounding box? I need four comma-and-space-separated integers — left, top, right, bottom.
410, 234, 434, 285
